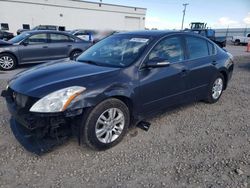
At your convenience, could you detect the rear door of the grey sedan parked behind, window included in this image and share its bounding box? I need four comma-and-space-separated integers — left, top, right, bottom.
49, 33, 74, 59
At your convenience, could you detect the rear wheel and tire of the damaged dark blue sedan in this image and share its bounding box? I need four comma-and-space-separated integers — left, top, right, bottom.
205, 73, 226, 104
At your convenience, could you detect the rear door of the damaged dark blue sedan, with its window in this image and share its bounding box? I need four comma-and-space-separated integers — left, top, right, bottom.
185, 36, 217, 98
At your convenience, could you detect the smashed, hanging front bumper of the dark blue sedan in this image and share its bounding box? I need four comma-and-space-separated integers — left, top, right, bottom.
1, 89, 83, 155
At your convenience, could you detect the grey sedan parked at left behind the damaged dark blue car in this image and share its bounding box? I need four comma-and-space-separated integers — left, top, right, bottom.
0, 30, 91, 70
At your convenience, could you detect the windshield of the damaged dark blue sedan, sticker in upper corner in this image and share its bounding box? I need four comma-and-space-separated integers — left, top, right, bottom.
77, 35, 149, 67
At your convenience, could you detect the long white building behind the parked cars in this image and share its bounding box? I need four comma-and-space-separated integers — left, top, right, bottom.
0, 0, 146, 33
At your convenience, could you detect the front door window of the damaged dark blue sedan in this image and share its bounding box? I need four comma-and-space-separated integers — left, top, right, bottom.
148, 37, 184, 63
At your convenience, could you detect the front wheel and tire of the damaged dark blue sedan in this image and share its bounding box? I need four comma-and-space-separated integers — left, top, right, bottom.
81, 98, 130, 150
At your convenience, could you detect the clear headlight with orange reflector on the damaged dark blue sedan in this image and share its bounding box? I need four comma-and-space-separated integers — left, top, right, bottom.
30, 86, 86, 112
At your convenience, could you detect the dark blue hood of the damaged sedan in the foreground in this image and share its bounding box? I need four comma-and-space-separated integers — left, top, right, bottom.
9, 60, 119, 98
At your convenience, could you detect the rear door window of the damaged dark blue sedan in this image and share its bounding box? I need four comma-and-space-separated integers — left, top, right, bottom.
186, 37, 209, 59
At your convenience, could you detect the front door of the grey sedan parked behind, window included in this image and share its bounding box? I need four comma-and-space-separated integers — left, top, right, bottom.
19, 33, 49, 62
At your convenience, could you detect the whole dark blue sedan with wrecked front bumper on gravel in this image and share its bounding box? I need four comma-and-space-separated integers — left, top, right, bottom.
2, 31, 234, 154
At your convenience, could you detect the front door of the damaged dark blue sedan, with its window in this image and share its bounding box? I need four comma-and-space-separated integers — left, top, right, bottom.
139, 36, 187, 115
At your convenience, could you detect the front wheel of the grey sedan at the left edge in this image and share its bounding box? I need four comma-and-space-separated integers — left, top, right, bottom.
0, 53, 17, 71
